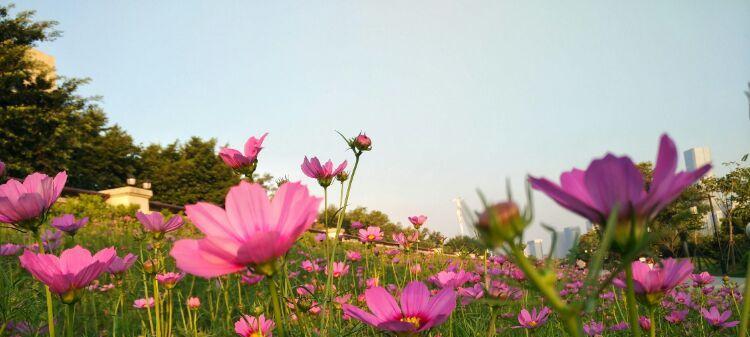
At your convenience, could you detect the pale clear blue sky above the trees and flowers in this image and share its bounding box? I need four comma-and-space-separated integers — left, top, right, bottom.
18, 0, 750, 249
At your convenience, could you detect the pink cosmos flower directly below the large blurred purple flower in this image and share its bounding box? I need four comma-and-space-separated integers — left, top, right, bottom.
614, 259, 693, 305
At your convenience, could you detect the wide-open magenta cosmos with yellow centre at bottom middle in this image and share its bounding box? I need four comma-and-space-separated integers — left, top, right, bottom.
342, 281, 456, 336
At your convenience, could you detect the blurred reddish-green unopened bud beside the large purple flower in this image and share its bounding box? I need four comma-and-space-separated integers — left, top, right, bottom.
475, 201, 526, 248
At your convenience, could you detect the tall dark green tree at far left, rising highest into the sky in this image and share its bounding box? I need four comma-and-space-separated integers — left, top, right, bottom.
0, 6, 138, 189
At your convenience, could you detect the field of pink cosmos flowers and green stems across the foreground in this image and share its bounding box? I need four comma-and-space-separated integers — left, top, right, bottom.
0, 134, 750, 337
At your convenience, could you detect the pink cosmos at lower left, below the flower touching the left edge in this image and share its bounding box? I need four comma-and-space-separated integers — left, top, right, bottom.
19, 246, 116, 303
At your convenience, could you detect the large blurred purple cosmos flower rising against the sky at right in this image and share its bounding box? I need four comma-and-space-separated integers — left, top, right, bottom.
529, 134, 711, 248
